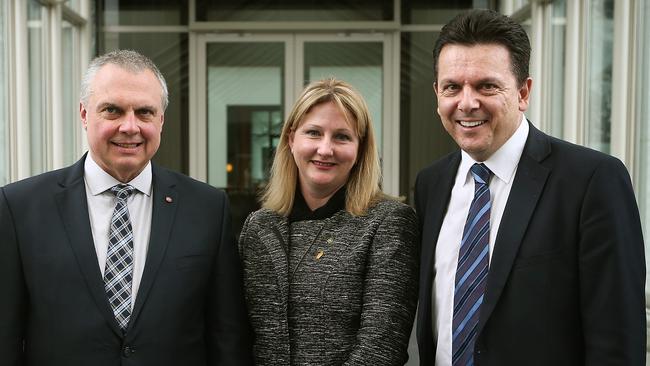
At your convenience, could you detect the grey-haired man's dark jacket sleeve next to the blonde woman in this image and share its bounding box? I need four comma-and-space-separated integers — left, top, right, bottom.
207, 194, 253, 366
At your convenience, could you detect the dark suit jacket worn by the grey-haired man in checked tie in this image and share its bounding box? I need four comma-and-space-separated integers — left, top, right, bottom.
0, 158, 251, 366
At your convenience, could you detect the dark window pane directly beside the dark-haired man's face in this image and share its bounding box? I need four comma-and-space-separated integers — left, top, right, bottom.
400, 32, 456, 203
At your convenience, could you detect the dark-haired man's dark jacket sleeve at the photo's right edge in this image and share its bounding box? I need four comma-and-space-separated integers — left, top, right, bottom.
579, 159, 646, 366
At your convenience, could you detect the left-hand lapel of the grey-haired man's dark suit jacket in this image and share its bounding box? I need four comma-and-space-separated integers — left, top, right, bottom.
55, 155, 122, 336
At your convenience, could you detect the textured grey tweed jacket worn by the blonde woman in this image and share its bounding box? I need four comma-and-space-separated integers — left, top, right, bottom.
239, 200, 419, 366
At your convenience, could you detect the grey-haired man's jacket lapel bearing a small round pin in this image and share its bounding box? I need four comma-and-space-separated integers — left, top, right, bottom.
129, 164, 179, 329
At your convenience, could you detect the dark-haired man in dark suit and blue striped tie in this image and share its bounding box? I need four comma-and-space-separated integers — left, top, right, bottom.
415, 10, 646, 366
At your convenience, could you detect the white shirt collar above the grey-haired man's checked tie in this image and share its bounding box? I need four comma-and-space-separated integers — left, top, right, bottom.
84, 153, 152, 196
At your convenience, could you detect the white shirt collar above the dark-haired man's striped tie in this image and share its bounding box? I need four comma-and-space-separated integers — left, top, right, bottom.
457, 115, 529, 184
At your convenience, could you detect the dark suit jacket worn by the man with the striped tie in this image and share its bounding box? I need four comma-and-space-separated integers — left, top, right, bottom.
416, 124, 646, 366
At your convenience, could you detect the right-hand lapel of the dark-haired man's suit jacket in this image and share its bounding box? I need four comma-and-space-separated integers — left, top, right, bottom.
477, 123, 550, 333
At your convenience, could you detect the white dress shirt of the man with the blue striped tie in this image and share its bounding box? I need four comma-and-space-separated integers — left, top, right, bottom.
431, 117, 529, 366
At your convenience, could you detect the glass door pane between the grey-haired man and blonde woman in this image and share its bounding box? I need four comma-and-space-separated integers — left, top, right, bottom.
206, 42, 285, 234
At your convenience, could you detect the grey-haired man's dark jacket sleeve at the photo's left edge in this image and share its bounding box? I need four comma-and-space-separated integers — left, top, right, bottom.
0, 188, 27, 366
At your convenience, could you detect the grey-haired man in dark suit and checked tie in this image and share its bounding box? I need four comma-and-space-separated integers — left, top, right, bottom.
0, 51, 252, 366
